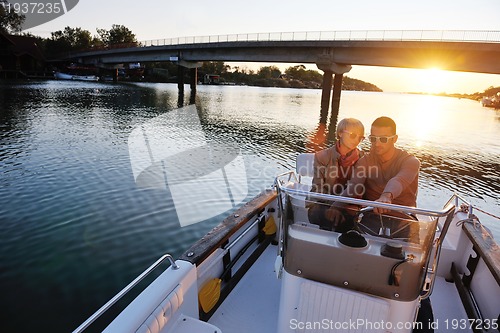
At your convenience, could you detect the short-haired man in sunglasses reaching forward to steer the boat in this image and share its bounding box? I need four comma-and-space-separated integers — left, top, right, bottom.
330, 117, 420, 240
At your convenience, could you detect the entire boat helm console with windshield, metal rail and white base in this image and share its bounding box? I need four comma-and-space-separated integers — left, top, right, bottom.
276, 172, 453, 332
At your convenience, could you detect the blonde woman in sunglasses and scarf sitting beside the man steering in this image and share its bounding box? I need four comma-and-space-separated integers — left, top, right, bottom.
308, 118, 365, 232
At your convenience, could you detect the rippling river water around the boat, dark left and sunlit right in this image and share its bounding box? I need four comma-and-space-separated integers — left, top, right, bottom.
0, 81, 500, 332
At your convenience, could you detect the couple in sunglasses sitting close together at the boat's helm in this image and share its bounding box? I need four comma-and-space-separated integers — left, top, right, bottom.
308, 117, 420, 238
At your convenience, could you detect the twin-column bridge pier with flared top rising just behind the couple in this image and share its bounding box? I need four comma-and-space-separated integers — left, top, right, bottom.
316, 62, 352, 139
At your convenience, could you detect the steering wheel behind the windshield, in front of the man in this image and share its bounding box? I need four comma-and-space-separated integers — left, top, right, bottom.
354, 207, 420, 243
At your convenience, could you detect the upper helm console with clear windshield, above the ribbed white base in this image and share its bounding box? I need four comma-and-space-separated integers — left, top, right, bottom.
281, 179, 438, 301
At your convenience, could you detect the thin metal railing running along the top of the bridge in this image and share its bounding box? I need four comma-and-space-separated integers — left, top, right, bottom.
140, 30, 500, 47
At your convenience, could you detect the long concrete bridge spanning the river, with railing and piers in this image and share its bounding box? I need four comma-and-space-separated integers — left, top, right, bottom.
63, 30, 500, 123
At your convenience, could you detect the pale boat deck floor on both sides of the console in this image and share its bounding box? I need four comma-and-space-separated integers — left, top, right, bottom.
209, 245, 472, 333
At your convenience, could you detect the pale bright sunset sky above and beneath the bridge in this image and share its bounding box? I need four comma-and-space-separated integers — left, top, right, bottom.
27, 0, 500, 93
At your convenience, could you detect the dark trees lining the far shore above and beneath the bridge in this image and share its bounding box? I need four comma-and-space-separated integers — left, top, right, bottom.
0, 10, 381, 91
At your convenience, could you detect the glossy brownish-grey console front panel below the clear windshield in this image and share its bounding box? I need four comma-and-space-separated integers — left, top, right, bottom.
284, 223, 430, 301
